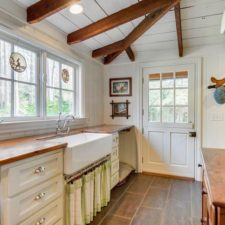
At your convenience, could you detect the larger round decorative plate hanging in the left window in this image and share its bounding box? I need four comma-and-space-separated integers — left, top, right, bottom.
9, 52, 27, 73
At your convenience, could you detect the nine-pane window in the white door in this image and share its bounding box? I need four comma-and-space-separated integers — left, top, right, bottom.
149, 71, 189, 123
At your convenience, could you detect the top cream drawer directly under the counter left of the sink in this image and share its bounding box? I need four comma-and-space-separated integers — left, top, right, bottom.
6, 151, 63, 197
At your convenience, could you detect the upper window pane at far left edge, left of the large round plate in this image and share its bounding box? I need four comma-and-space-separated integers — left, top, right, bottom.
0, 40, 12, 78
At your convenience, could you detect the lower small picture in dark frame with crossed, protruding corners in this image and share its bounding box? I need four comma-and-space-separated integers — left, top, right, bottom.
110, 100, 130, 119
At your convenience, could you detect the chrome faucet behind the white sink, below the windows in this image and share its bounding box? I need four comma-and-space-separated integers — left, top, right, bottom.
56, 112, 75, 135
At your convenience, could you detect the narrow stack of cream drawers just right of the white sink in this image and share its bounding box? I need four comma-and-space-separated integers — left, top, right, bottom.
111, 133, 119, 189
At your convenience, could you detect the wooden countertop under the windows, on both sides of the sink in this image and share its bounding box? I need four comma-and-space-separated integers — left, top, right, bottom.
0, 125, 133, 166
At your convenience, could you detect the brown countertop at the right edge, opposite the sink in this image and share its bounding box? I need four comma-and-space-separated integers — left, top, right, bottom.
202, 149, 225, 207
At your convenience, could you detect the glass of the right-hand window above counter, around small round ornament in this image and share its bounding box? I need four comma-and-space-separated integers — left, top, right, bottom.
46, 57, 75, 116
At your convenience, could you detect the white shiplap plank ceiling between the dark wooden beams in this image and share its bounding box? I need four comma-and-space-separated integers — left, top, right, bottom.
14, 0, 225, 55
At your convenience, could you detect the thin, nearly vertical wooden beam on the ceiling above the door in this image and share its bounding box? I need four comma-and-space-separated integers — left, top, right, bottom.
174, 3, 184, 57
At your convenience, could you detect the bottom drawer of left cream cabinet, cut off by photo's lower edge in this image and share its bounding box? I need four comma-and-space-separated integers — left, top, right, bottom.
19, 198, 63, 225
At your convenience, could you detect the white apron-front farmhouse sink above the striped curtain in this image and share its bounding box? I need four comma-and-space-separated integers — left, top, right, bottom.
48, 133, 112, 175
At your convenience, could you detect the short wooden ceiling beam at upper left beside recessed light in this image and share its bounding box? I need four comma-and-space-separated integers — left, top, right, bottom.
27, 0, 80, 23
